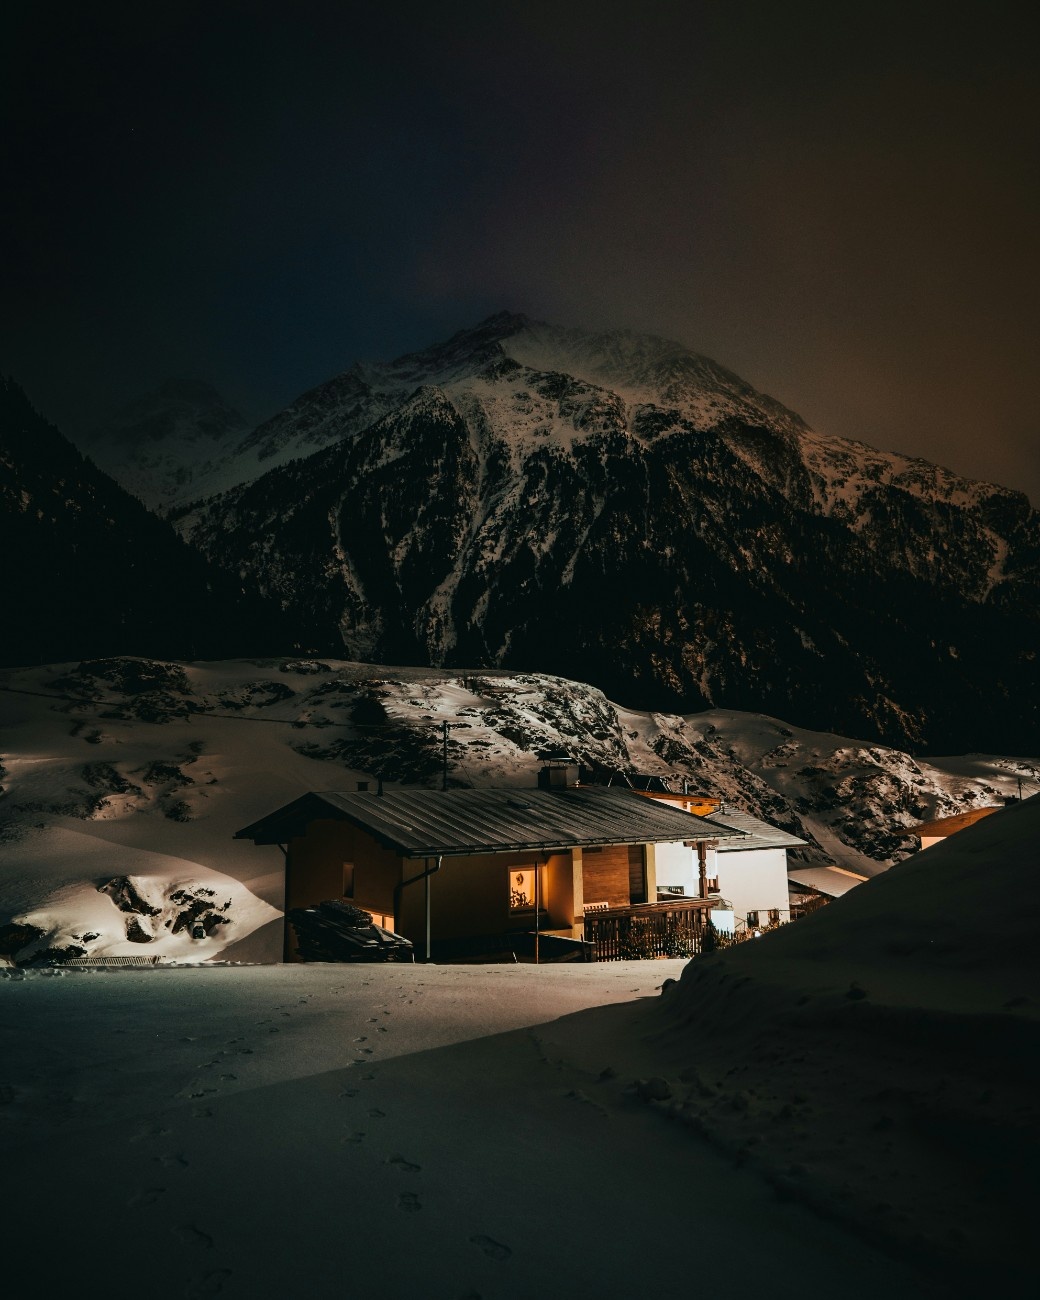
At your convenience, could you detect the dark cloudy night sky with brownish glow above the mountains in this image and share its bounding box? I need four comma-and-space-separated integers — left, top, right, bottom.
0, 0, 1040, 503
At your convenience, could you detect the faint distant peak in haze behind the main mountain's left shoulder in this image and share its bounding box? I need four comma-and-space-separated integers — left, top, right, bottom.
82, 377, 250, 512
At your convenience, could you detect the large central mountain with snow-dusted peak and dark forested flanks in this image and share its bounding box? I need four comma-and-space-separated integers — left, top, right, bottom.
150, 315, 1040, 751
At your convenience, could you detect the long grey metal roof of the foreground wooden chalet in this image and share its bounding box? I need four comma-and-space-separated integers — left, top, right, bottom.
235, 787, 742, 858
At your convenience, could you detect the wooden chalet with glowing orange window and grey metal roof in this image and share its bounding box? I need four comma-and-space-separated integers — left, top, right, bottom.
235, 770, 745, 958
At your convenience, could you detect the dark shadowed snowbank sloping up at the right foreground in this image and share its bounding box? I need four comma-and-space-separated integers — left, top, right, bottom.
657, 800, 1040, 1296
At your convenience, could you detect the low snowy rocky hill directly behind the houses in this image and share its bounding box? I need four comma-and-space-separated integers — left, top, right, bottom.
0, 658, 1040, 961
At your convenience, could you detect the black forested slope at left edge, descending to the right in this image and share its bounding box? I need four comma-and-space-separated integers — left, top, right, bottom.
0, 380, 291, 664
